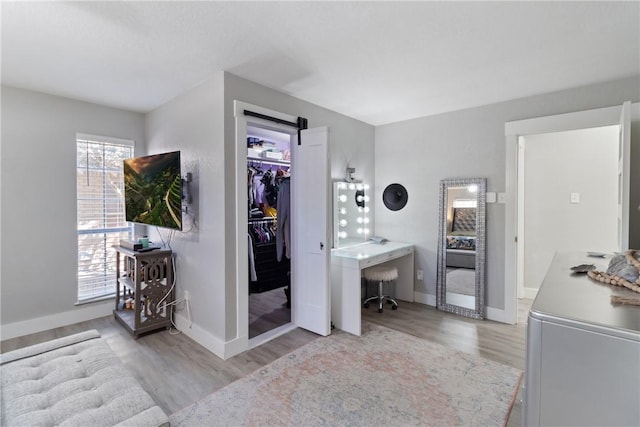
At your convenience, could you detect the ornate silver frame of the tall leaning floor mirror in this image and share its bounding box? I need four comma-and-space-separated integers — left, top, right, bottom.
436, 178, 487, 319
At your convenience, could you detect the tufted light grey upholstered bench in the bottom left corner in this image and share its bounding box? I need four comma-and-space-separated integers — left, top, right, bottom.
0, 330, 169, 426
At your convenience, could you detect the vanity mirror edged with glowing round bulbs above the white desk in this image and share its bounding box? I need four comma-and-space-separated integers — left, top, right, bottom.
333, 182, 371, 248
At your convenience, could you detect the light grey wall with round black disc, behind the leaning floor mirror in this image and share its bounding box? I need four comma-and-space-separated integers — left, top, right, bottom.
374, 76, 640, 314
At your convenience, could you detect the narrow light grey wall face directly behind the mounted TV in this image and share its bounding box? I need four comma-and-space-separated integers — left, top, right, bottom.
146, 72, 228, 354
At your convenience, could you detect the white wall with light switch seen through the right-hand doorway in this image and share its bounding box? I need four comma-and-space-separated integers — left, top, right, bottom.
524, 126, 619, 289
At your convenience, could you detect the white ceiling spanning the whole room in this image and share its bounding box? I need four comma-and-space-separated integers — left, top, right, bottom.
1, 1, 640, 125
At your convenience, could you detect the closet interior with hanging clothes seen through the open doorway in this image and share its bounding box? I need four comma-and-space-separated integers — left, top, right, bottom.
247, 127, 293, 338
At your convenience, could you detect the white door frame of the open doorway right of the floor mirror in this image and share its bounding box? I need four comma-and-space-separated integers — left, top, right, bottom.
504, 103, 638, 324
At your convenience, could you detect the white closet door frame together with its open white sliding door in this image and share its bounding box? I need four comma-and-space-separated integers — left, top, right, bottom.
234, 101, 331, 354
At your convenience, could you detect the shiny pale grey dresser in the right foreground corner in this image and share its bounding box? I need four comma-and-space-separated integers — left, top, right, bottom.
522, 253, 640, 426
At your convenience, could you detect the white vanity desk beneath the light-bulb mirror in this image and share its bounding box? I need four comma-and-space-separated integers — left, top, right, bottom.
331, 241, 414, 335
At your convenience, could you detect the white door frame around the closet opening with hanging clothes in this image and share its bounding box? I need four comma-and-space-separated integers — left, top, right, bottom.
232, 100, 298, 354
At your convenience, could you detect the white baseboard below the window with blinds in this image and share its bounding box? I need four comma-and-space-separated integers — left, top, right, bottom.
1, 300, 114, 340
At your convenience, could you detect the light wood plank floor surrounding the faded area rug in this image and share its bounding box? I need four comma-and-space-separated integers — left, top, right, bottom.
0, 300, 531, 426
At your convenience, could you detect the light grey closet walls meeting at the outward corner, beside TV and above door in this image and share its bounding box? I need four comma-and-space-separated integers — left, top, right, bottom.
146, 72, 374, 356
